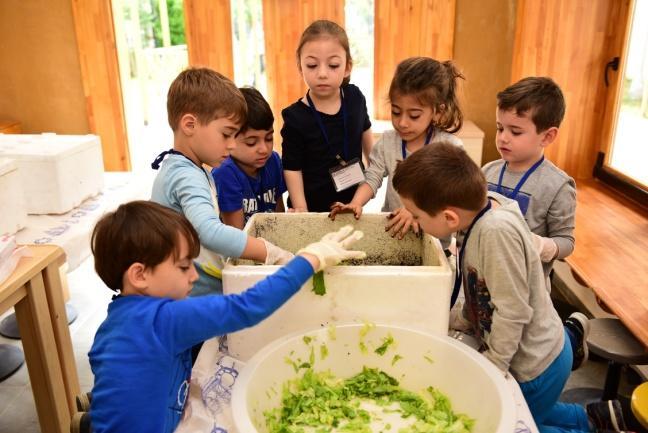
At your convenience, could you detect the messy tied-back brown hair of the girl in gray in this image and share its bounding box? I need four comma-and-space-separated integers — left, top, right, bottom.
389, 57, 465, 133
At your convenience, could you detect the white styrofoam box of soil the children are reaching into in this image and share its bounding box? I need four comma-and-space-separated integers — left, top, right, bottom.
223, 213, 452, 361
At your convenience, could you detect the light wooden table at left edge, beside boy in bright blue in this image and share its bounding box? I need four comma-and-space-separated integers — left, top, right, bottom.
0, 245, 80, 433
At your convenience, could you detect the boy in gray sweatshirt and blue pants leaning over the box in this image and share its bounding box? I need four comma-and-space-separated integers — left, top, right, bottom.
393, 143, 623, 432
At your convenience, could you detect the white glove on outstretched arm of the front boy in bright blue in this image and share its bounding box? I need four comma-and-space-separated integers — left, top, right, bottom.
297, 226, 367, 272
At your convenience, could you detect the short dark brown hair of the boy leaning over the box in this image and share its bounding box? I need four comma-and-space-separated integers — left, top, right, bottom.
392, 142, 486, 215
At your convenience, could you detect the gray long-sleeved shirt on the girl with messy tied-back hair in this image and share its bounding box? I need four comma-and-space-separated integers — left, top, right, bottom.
365, 130, 463, 212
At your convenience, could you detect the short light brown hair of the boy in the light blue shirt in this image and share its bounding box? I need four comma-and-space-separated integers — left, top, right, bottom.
167, 68, 247, 131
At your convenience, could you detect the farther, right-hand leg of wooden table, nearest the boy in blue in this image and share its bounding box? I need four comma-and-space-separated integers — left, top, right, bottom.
43, 263, 81, 416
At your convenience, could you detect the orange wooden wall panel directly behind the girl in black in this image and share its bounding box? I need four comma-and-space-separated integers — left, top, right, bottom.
263, 0, 344, 150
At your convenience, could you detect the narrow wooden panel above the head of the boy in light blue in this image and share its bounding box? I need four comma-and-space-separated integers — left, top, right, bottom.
184, 0, 234, 80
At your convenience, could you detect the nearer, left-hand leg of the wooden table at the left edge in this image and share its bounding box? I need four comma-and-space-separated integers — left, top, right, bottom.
15, 273, 70, 433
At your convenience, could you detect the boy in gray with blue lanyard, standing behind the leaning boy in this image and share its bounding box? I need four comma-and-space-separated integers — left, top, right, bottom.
482, 77, 589, 370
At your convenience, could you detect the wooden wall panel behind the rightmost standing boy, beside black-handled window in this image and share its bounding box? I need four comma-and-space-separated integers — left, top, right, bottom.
511, 0, 624, 179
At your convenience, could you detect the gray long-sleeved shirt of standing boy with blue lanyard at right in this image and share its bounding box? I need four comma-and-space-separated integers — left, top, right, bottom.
482, 159, 576, 277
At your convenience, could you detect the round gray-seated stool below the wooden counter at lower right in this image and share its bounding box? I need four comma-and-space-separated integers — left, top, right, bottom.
587, 319, 648, 400
